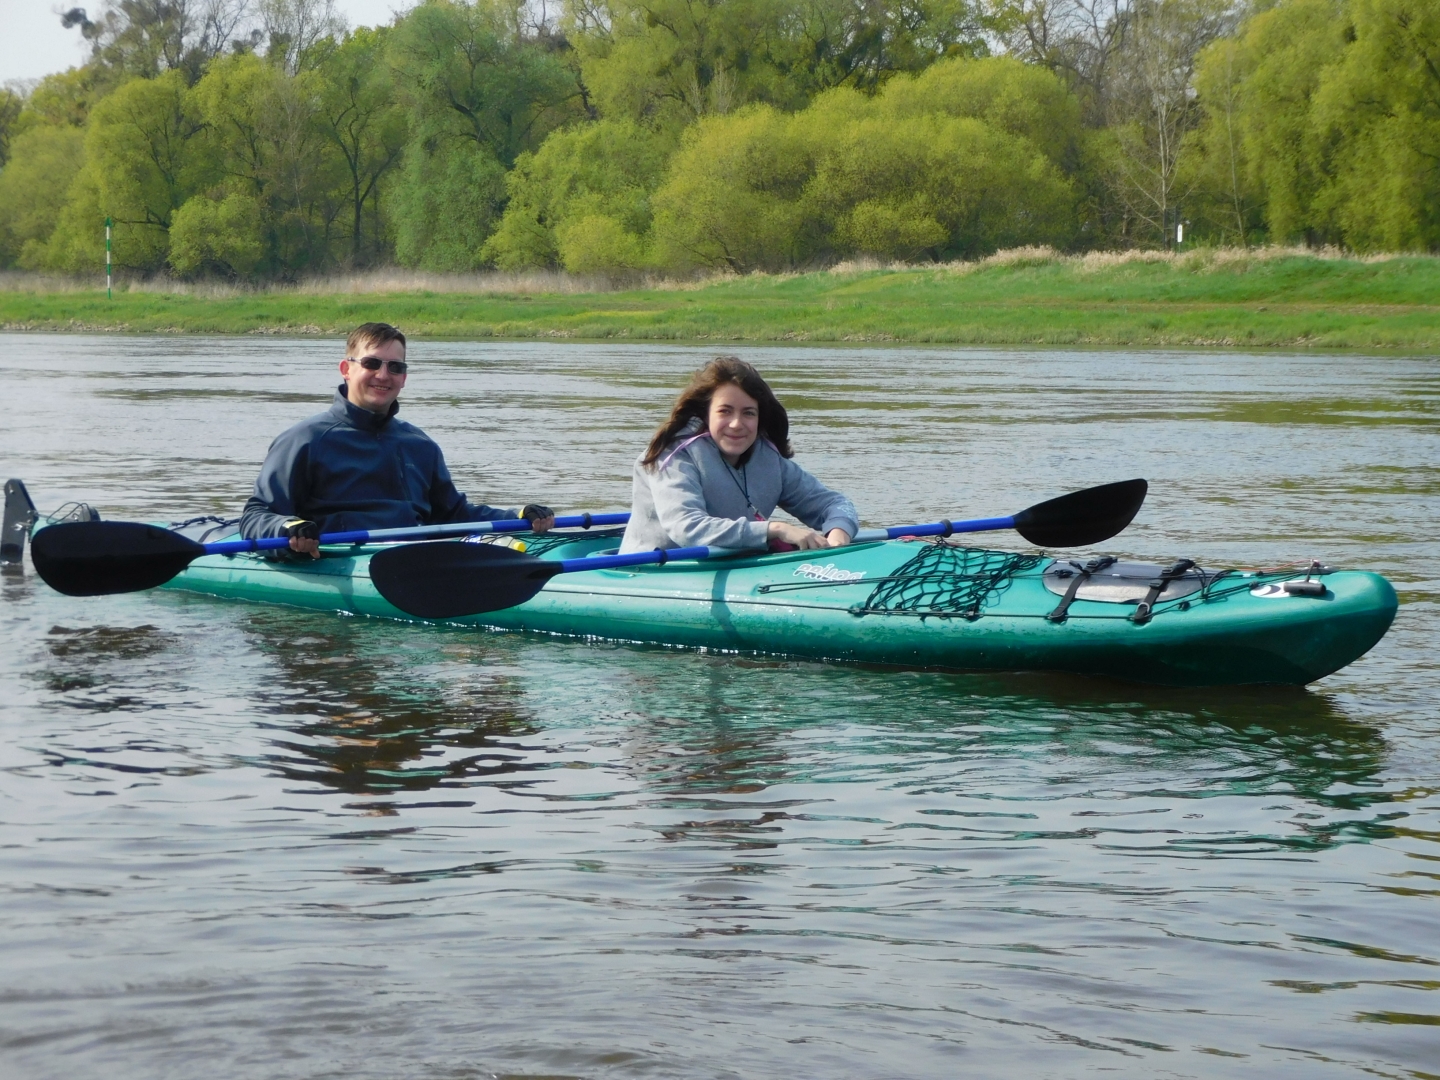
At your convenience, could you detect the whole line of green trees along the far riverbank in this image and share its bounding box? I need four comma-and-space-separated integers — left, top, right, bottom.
0, 0, 1440, 281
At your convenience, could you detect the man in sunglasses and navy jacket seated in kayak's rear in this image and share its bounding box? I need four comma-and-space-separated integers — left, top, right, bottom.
240, 323, 554, 557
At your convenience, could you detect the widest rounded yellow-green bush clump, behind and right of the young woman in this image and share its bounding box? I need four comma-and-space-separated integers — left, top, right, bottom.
654, 60, 1079, 272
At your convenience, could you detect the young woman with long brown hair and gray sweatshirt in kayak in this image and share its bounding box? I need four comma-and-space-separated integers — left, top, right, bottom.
621, 356, 860, 553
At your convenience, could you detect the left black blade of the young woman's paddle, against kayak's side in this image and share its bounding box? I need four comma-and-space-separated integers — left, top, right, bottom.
370, 540, 560, 619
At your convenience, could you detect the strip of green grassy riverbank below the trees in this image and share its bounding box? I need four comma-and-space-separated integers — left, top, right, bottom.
0, 251, 1440, 351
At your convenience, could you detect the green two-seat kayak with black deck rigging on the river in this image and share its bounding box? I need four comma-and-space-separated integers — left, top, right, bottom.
146, 531, 1397, 685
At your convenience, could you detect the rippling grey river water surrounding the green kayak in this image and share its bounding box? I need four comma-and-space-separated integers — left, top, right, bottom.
0, 334, 1440, 1080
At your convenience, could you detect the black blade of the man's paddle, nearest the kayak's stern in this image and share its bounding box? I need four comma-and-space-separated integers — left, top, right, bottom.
30, 521, 204, 596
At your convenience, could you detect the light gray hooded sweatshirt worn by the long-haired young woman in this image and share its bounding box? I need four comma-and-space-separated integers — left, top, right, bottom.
621, 419, 860, 554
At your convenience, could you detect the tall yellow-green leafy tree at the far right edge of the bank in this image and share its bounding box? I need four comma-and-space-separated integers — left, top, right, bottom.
1197, 0, 1440, 251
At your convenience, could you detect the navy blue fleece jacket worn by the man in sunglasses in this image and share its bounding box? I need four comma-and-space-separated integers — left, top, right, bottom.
240, 383, 517, 539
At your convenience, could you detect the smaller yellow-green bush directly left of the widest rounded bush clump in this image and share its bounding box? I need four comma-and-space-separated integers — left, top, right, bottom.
484, 120, 674, 272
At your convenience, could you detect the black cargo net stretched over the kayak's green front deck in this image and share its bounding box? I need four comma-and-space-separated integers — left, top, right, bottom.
851, 541, 1045, 619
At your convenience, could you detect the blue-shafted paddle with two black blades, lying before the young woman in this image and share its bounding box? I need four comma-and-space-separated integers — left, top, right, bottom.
370, 480, 1148, 619
